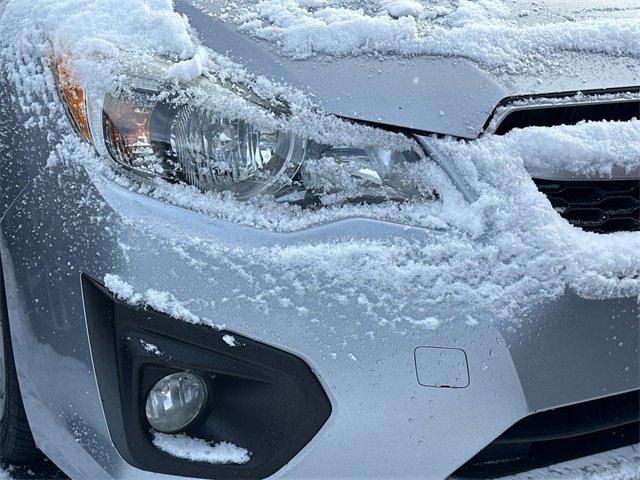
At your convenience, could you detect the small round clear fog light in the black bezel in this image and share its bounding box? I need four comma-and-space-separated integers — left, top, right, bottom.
145, 372, 207, 433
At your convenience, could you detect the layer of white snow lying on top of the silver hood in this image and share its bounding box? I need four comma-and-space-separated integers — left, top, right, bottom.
204, 0, 640, 71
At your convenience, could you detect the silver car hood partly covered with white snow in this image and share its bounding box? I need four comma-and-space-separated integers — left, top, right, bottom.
176, 0, 640, 138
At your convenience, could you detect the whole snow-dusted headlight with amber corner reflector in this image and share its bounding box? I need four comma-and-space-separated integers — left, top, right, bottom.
55, 56, 432, 204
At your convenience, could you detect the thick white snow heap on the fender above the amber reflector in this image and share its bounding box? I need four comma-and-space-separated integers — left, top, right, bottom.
0, 0, 198, 126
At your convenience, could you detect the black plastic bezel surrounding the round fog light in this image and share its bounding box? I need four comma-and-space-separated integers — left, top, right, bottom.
82, 275, 331, 479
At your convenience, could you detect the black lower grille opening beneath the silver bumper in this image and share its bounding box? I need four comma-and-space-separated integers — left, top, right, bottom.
453, 391, 640, 479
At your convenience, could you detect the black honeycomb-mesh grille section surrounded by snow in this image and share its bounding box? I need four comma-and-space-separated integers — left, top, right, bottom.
534, 179, 640, 233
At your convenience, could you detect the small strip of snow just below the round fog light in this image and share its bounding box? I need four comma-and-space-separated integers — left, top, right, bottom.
153, 432, 251, 465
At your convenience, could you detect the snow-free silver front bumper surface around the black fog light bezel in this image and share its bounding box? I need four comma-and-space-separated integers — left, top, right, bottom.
1, 159, 639, 479
